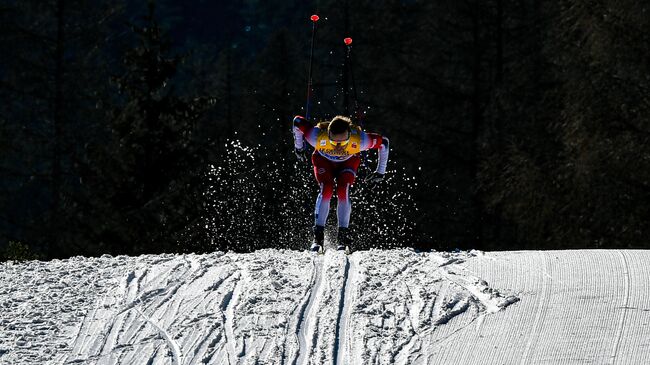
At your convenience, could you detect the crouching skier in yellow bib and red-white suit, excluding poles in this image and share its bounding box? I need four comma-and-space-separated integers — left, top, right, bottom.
293, 115, 389, 251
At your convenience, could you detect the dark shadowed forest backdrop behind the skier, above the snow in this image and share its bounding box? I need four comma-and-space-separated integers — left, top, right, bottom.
0, 0, 650, 259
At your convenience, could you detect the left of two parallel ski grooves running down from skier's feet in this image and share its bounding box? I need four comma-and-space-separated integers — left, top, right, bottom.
292, 255, 323, 365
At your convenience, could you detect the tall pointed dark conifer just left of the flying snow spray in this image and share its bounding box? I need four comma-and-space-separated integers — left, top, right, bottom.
83, 2, 213, 253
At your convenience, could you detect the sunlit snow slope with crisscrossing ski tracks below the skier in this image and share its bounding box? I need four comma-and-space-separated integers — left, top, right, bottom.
0, 250, 650, 364
